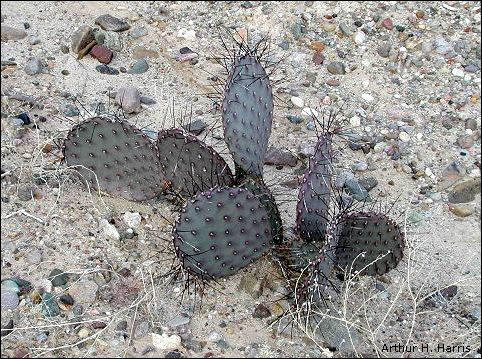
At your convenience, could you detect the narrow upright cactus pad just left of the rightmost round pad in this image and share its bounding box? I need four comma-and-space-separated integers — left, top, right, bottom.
295, 135, 333, 242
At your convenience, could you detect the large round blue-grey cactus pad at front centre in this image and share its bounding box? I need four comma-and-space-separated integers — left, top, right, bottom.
173, 187, 272, 279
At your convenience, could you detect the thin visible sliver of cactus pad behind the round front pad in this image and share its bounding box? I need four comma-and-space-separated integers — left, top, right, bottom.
241, 177, 283, 244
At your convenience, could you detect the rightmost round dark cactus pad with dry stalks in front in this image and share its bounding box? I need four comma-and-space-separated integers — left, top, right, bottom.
336, 212, 405, 275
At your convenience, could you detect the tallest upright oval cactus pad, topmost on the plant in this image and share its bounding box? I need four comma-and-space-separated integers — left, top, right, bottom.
222, 54, 274, 177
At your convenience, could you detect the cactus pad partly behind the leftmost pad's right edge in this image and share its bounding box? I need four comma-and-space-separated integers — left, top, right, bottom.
157, 129, 233, 196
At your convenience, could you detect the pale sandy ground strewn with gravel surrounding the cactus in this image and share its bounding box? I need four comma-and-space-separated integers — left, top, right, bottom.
1, 1, 481, 358
